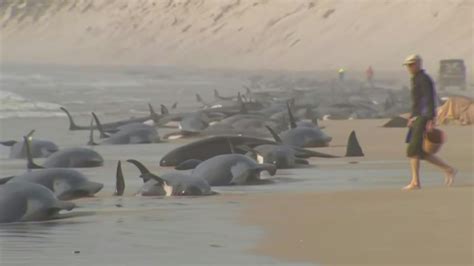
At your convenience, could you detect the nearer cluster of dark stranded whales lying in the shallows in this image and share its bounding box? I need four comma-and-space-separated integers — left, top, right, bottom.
0, 87, 378, 223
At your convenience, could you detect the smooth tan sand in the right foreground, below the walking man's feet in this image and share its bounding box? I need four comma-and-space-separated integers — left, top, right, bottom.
240, 185, 474, 265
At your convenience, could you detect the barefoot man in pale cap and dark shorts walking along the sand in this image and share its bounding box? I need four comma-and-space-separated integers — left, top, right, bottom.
403, 55, 457, 190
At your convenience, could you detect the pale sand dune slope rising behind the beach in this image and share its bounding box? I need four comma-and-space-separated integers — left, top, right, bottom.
0, 0, 474, 71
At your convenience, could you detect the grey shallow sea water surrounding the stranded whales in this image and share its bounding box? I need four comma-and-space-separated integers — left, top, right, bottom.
0, 66, 468, 265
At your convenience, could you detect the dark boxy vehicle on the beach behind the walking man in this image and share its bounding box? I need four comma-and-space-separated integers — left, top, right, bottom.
438, 59, 466, 90
